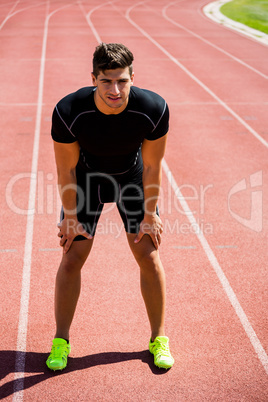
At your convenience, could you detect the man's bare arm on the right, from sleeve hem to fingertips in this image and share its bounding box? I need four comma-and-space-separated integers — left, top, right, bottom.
135, 134, 167, 248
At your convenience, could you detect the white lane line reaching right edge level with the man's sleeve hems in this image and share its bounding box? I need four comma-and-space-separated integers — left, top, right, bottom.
126, 2, 268, 148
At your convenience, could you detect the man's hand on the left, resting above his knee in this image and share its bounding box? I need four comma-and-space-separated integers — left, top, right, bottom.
57, 218, 92, 254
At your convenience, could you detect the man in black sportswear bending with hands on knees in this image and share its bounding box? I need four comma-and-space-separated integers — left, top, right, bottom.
46, 43, 174, 370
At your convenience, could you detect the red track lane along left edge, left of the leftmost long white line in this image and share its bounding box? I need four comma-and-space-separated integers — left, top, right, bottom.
0, 2, 49, 394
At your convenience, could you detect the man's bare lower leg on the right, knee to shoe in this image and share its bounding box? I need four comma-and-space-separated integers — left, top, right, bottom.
127, 233, 166, 340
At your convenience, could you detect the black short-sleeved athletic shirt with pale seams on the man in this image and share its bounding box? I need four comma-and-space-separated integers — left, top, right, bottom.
51, 86, 169, 174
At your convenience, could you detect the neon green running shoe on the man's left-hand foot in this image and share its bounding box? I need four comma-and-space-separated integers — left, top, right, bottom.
46, 338, 71, 371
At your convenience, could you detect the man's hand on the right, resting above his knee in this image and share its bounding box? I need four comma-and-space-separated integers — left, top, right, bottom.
134, 214, 163, 249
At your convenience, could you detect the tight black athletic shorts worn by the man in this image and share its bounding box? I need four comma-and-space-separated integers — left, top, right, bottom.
61, 165, 147, 241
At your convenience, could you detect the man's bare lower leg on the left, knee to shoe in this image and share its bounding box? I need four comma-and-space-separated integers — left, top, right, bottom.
55, 239, 93, 339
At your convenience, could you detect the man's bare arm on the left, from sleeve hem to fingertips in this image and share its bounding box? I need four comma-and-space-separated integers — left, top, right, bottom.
54, 141, 91, 253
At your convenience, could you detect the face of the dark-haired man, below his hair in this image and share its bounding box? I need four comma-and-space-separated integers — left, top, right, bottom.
92, 67, 134, 114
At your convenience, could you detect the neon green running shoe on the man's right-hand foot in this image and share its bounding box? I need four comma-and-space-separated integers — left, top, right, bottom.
149, 336, 174, 369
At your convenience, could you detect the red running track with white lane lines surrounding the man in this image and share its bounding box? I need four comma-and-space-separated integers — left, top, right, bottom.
0, 0, 268, 401
